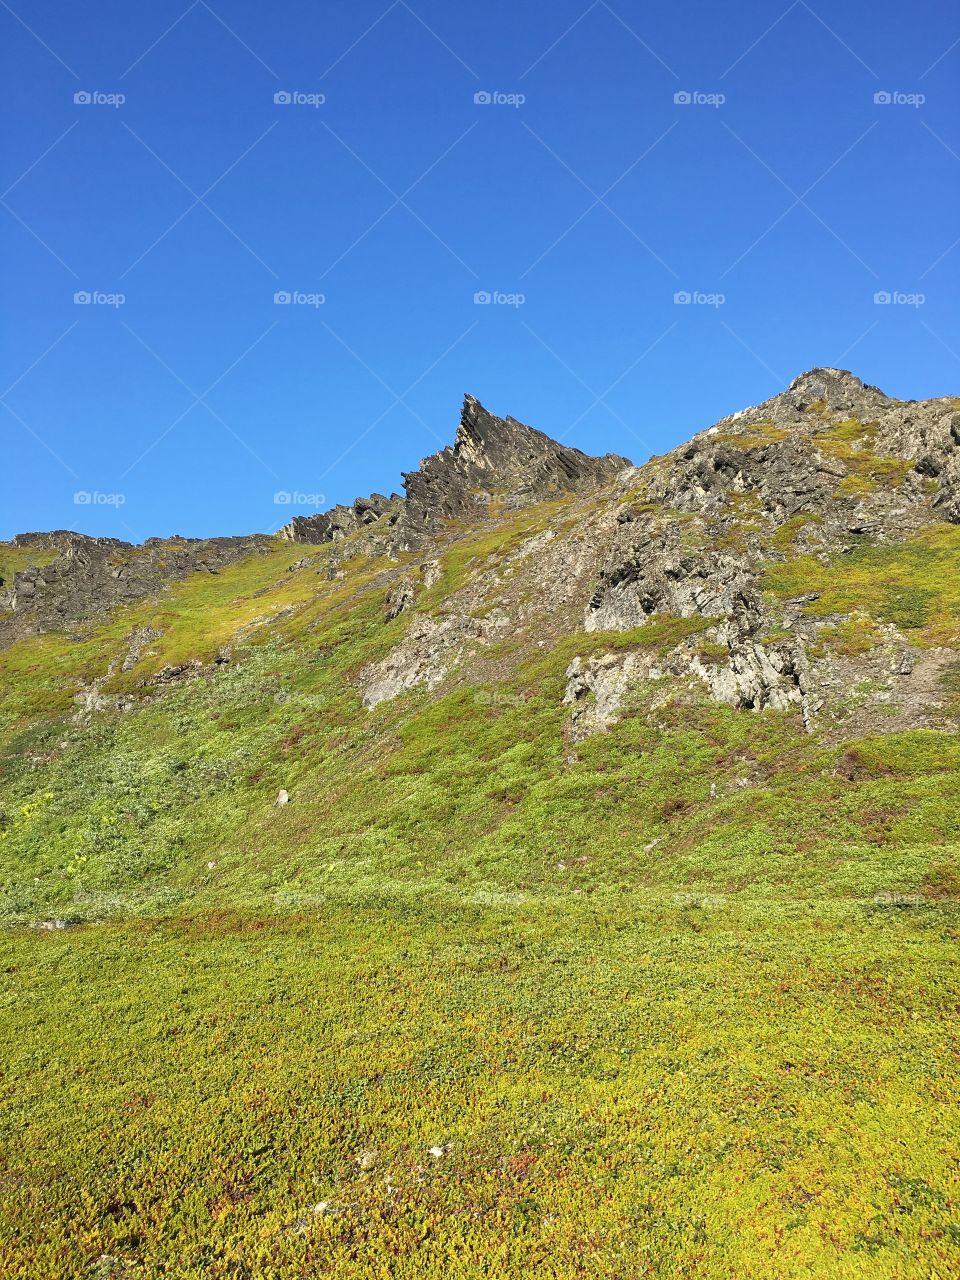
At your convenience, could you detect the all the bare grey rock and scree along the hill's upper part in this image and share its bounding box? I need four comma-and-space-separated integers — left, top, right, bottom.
0, 369, 960, 742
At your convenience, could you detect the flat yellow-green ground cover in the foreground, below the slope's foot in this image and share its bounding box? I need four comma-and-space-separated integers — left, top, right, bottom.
0, 900, 960, 1280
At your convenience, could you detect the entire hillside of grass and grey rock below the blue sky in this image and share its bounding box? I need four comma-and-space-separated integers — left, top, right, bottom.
0, 369, 960, 1280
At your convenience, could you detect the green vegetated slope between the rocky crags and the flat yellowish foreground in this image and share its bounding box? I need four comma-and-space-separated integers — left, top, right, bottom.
0, 596, 960, 922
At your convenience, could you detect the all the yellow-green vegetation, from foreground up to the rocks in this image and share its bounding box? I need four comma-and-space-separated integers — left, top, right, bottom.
0, 509, 960, 1277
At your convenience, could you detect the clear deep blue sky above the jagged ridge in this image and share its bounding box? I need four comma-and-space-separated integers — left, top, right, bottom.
0, 0, 960, 539
